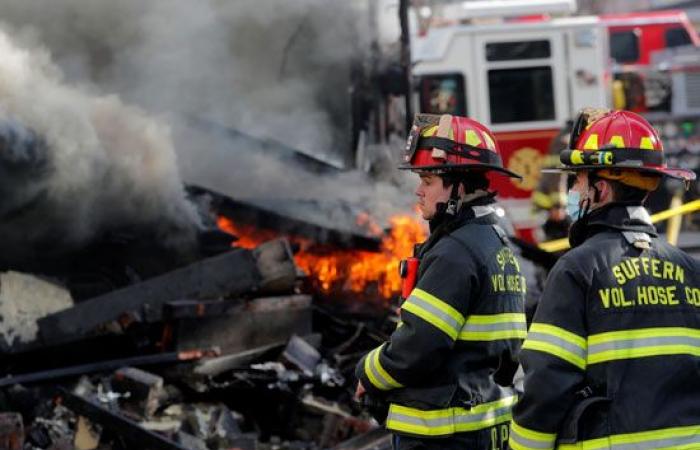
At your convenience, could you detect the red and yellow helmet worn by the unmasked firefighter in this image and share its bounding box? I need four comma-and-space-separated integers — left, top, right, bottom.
399, 114, 521, 178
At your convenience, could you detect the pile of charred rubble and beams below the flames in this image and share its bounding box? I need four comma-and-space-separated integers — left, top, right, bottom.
0, 230, 395, 450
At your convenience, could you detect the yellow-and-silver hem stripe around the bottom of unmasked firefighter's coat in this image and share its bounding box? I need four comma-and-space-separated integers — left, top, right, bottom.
386, 395, 517, 436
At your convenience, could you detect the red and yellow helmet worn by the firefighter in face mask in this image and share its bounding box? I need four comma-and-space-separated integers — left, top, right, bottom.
560, 111, 695, 190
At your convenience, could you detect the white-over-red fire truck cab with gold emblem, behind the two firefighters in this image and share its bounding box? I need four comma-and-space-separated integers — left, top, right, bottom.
411, 17, 611, 240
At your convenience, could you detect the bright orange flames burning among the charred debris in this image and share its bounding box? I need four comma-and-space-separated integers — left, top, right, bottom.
218, 215, 426, 298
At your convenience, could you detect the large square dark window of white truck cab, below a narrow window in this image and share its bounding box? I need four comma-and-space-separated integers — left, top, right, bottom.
488, 66, 555, 124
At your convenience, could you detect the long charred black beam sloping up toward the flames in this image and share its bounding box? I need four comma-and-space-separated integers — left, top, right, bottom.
39, 249, 261, 345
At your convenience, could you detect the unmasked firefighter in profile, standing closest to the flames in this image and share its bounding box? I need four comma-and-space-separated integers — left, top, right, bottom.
356, 114, 526, 450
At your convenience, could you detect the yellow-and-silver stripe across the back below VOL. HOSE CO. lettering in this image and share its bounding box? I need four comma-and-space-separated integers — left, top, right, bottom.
587, 327, 700, 364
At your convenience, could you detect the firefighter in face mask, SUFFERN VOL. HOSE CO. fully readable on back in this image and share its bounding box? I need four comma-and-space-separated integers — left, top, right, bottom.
510, 110, 700, 450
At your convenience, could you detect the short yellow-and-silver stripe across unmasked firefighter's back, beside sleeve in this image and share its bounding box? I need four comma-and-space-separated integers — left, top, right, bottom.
458, 313, 527, 341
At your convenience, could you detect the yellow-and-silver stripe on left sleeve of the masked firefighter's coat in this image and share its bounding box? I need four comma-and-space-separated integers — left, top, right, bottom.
522, 323, 587, 370
